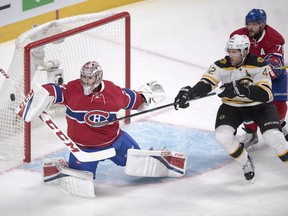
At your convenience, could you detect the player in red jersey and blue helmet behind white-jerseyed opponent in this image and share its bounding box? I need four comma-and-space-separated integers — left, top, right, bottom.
230, 9, 288, 149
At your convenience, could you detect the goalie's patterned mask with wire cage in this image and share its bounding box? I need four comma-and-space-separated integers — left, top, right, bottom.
80, 61, 103, 95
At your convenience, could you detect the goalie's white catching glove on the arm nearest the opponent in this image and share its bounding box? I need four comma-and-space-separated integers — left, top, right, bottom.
139, 81, 166, 105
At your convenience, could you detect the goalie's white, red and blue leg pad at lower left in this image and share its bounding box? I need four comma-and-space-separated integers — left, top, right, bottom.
42, 158, 95, 198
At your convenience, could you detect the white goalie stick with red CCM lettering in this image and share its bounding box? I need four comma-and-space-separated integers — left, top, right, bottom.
0, 68, 116, 162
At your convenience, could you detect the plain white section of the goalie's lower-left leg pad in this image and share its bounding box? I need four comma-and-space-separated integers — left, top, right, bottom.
59, 167, 95, 198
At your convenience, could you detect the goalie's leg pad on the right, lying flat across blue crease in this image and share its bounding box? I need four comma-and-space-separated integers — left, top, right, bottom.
125, 149, 187, 177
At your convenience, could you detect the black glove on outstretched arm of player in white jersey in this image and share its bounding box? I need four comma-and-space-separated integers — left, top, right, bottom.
174, 86, 198, 110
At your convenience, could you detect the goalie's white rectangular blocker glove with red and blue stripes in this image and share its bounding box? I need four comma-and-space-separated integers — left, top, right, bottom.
15, 83, 54, 122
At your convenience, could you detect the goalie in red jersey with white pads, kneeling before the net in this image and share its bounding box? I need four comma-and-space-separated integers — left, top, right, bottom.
17, 61, 186, 198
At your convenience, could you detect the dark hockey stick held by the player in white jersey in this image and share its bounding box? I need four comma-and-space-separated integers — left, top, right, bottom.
93, 92, 216, 127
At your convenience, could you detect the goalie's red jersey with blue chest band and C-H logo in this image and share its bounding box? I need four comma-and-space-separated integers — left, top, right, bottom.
43, 79, 144, 148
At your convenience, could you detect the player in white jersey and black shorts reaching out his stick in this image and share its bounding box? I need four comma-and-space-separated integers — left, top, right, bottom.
175, 35, 288, 182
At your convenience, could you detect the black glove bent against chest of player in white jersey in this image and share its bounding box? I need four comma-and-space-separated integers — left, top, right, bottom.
218, 80, 249, 98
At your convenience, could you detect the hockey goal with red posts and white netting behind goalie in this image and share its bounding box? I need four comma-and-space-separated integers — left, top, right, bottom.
0, 12, 131, 162
